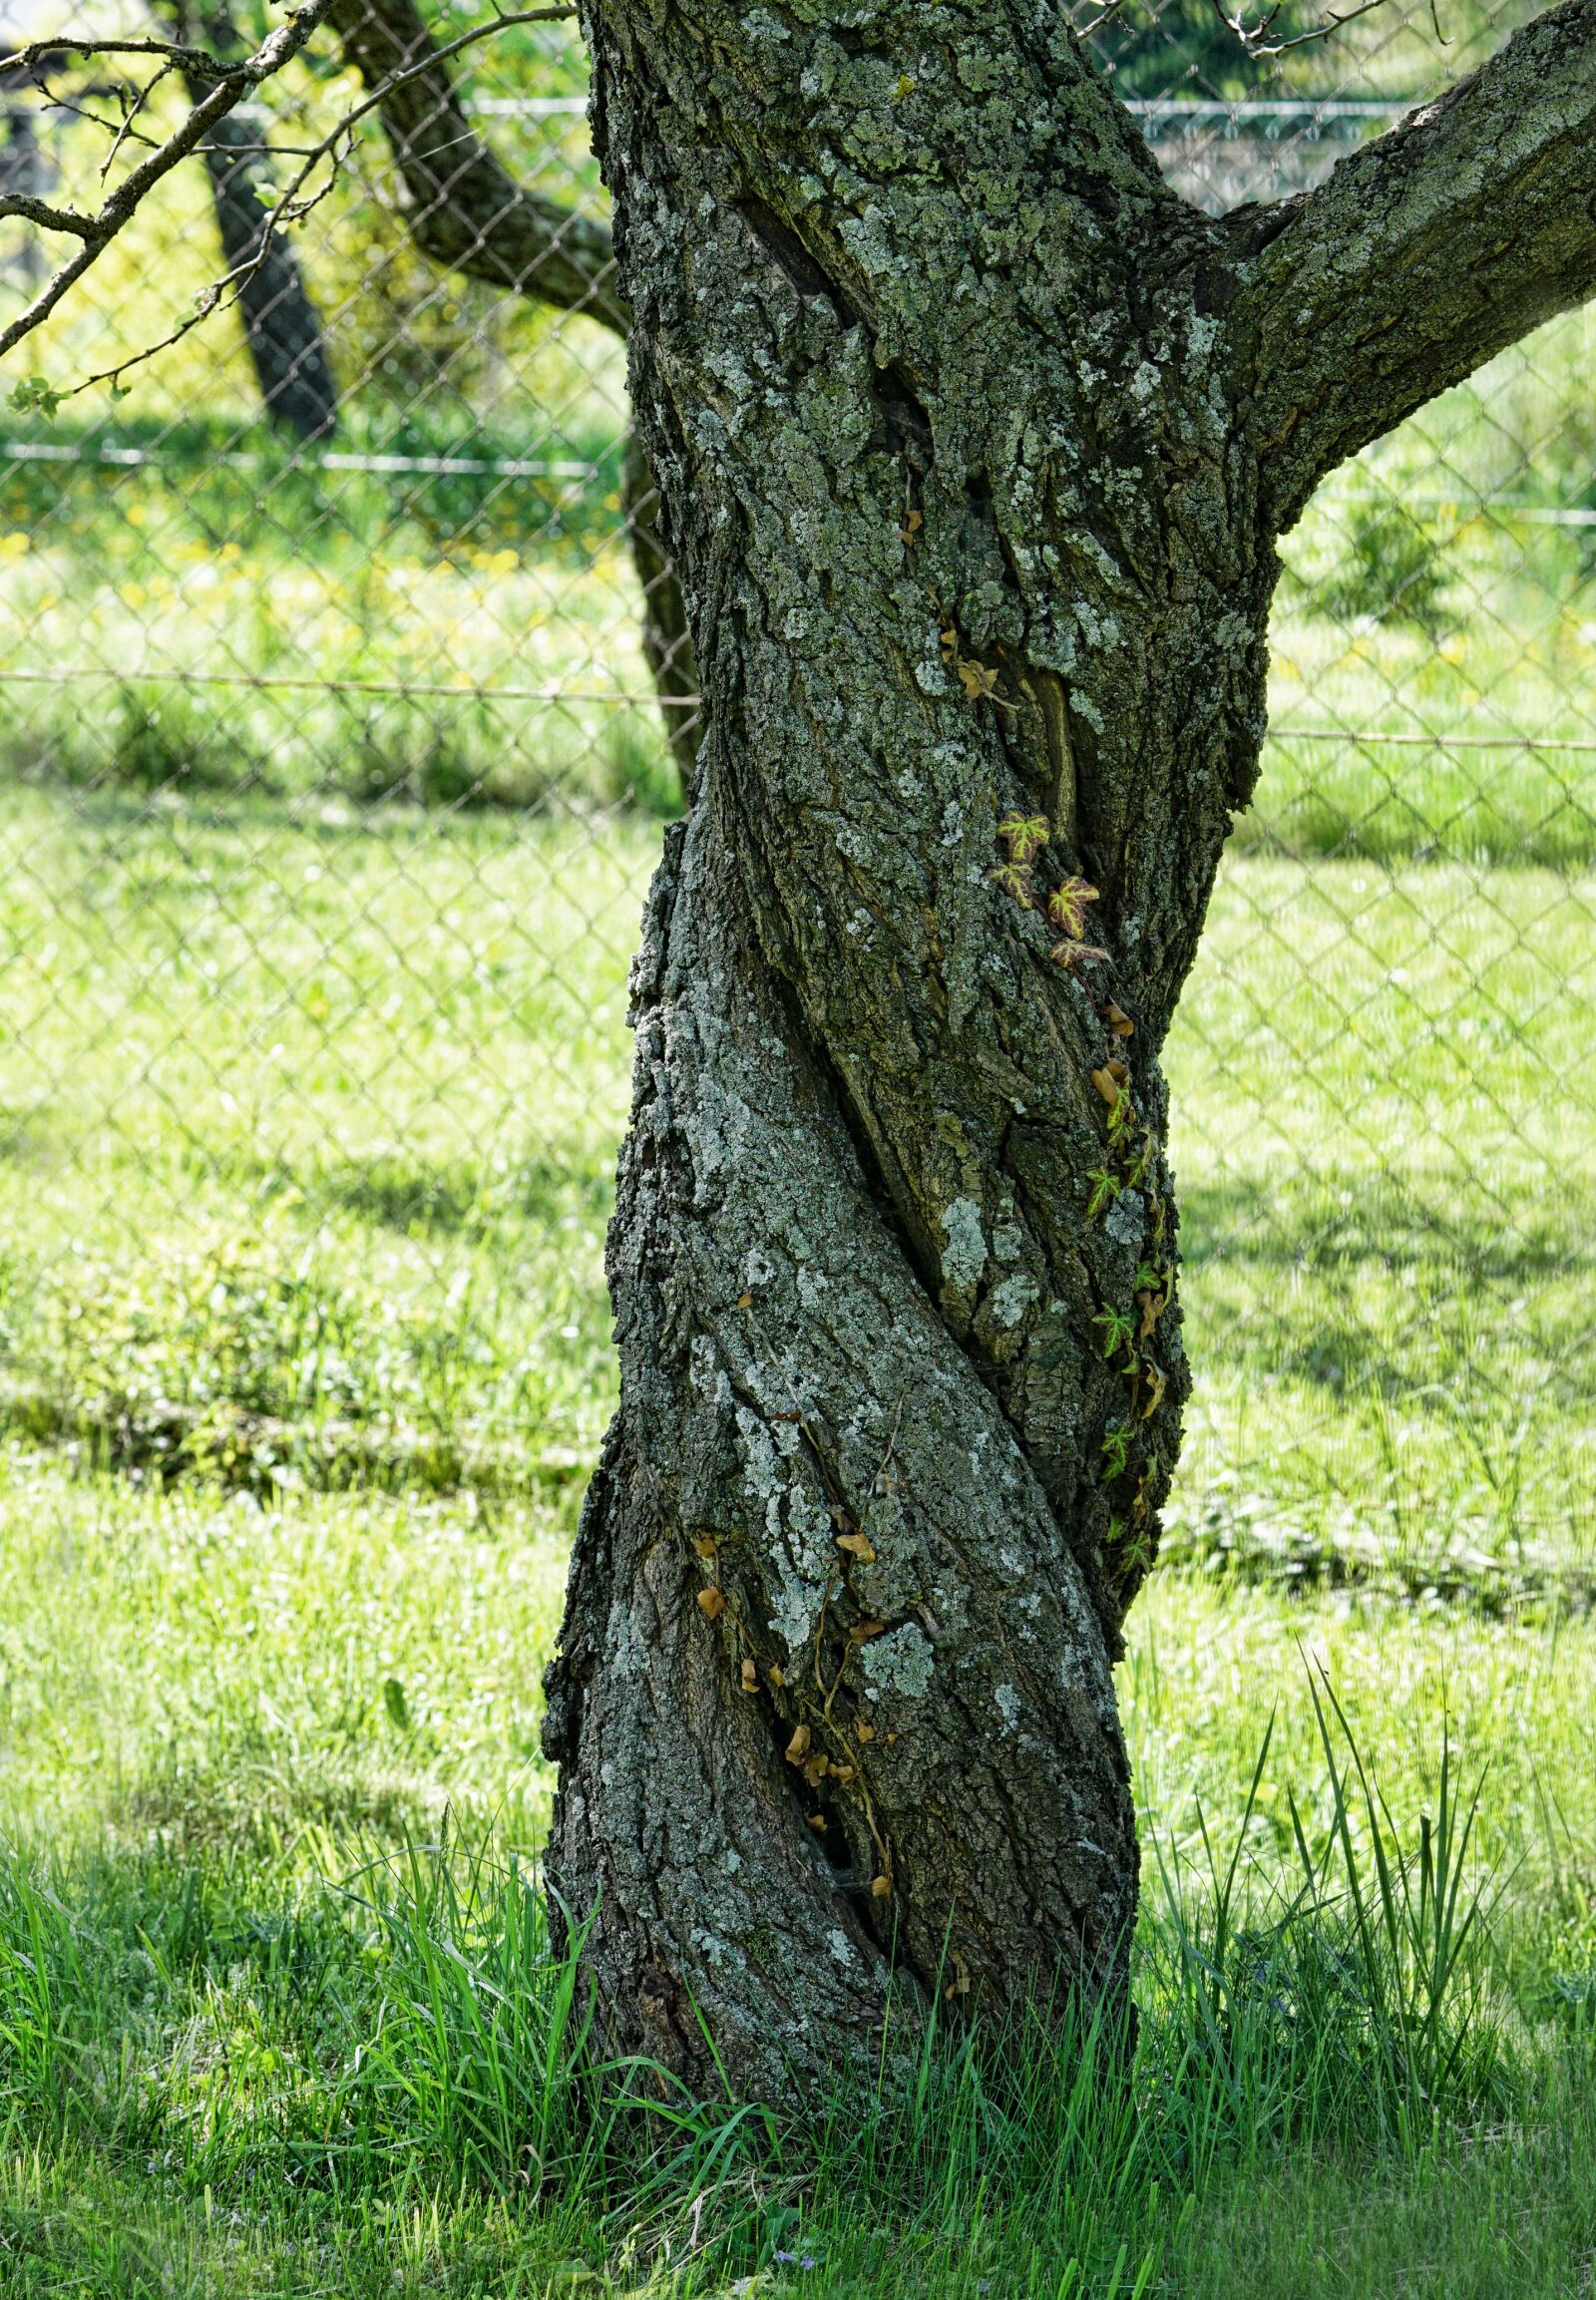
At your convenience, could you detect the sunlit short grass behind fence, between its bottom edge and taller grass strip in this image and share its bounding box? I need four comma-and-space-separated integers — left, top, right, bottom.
0, 789, 1596, 1603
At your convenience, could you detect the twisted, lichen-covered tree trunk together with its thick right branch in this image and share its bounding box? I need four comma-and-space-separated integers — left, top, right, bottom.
533, 0, 1596, 2098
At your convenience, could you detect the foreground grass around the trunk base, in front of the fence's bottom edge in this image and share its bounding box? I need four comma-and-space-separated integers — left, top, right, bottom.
0, 1453, 1596, 2295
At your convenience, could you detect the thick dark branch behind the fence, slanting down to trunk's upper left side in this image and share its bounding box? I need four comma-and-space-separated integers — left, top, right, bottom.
331, 0, 630, 336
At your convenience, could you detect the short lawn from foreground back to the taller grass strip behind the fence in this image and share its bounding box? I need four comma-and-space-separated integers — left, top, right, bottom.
0, 780, 1596, 2300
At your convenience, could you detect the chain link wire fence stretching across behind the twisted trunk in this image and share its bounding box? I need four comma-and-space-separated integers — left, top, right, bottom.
0, 0, 1596, 1603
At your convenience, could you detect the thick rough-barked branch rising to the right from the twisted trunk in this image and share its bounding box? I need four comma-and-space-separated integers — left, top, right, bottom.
1230, 0, 1596, 527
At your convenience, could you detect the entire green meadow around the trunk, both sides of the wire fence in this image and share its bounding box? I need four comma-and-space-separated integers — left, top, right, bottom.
0, 67, 1596, 2300
